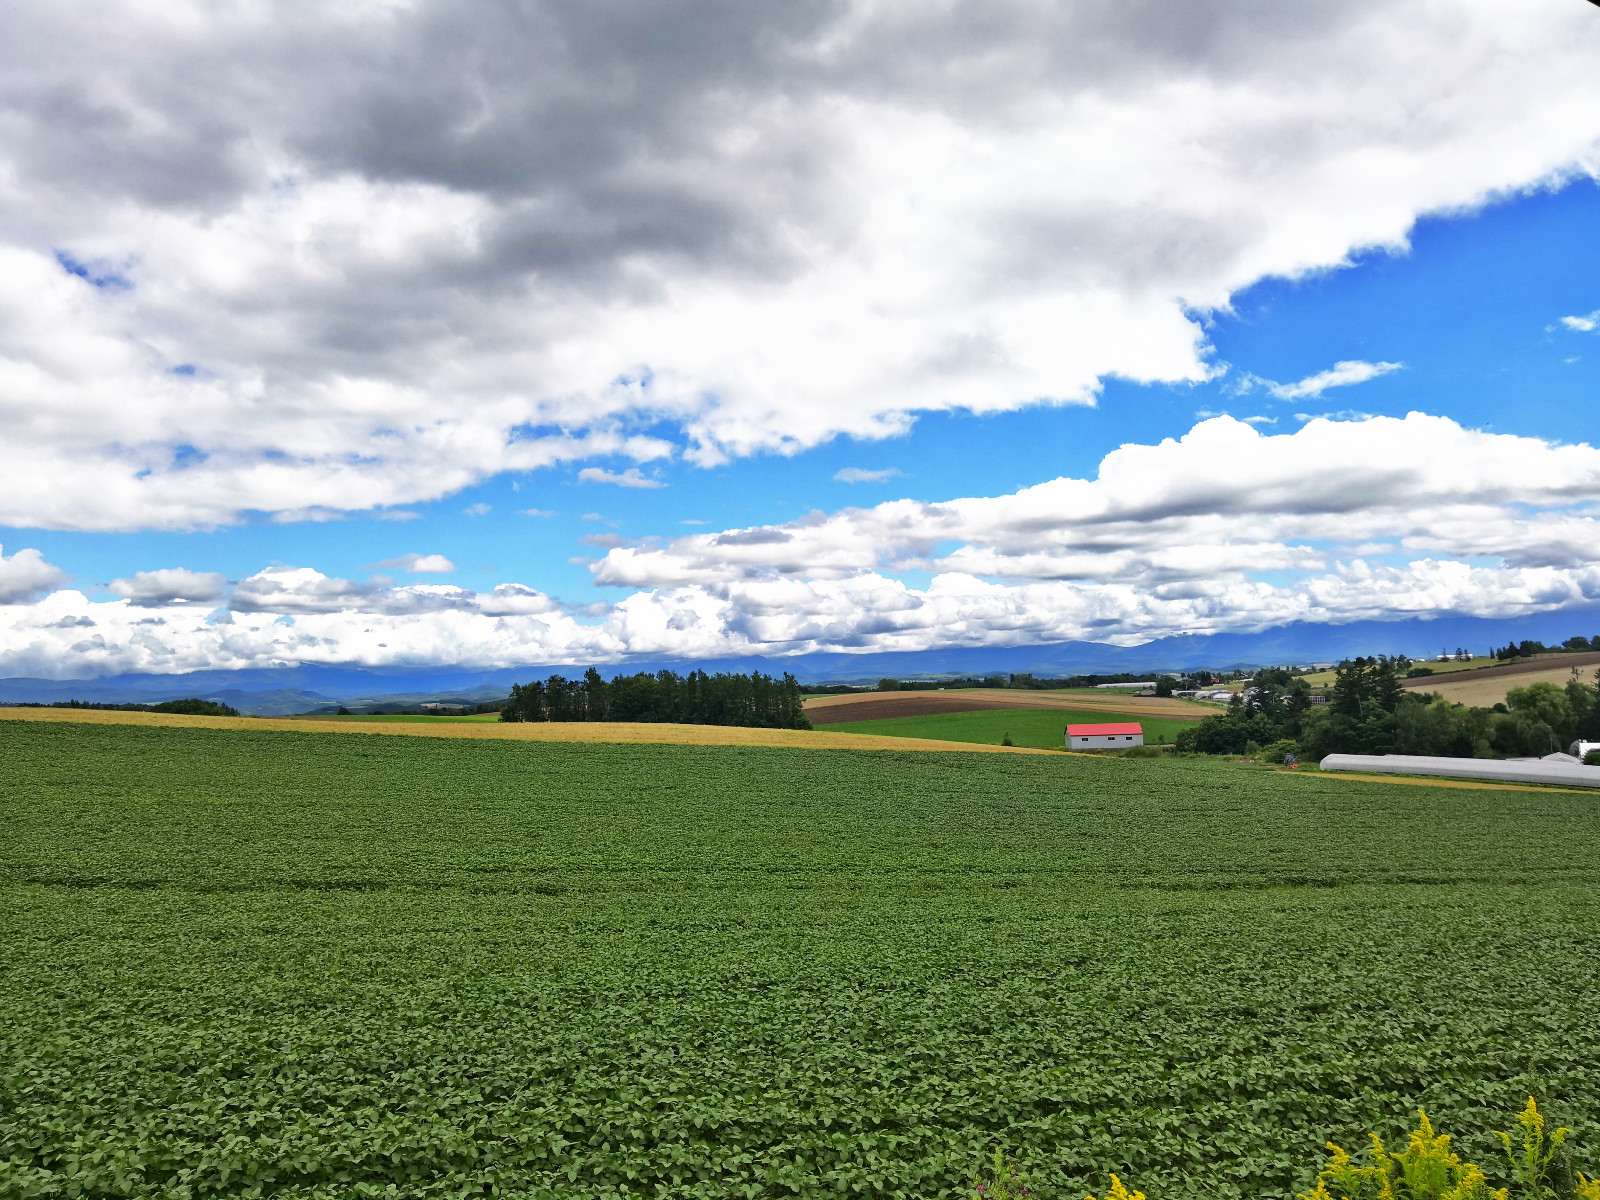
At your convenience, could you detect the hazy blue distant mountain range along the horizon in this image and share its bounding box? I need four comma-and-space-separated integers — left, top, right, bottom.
0, 608, 1600, 715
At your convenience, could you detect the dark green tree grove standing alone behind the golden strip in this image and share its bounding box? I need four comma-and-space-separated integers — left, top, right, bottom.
501, 667, 811, 730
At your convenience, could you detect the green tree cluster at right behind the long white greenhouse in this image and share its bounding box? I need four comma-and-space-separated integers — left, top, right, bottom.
1174, 654, 1600, 762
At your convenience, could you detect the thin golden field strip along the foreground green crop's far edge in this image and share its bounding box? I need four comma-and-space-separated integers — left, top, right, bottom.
0, 707, 1066, 754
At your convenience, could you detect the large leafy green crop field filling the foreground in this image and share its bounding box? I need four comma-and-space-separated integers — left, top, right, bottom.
0, 722, 1600, 1200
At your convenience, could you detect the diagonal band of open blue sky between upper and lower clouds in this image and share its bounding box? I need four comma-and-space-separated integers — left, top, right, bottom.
15, 179, 1600, 602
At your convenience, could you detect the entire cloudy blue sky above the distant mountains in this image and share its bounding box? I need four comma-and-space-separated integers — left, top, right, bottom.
0, 0, 1600, 678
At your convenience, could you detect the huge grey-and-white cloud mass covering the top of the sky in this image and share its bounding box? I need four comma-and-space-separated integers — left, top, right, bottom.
0, 0, 1600, 530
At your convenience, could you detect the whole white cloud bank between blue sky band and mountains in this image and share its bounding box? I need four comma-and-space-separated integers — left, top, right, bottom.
0, 414, 1600, 677
